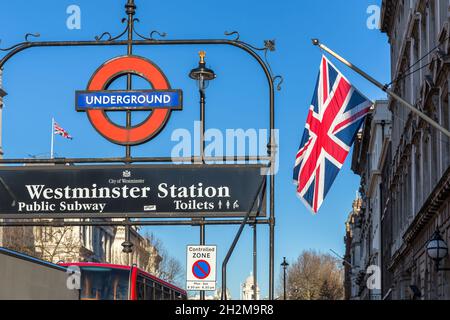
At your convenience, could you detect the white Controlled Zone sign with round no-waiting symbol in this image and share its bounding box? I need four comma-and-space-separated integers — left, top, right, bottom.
186, 246, 217, 291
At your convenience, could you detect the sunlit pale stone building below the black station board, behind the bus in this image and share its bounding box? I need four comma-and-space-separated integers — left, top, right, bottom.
0, 226, 162, 276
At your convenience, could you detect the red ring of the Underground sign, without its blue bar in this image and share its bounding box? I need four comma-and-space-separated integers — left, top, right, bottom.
87, 56, 171, 145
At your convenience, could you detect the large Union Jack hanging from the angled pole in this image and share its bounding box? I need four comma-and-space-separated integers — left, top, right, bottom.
294, 56, 372, 213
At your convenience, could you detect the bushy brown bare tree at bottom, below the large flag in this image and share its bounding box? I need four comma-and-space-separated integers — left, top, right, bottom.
286, 250, 344, 300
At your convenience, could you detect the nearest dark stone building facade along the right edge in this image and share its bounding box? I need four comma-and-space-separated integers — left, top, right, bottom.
350, 0, 450, 299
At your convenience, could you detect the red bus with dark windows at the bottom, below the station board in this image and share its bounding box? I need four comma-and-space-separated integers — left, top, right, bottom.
60, 262, 187, 300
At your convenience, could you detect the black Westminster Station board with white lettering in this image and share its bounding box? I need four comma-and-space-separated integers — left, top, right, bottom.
0, 165, 266, 218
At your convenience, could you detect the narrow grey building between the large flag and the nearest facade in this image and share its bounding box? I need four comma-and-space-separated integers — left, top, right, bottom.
347, 100, 391, 300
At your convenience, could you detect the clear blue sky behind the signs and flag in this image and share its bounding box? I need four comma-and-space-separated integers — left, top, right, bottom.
0, 0, 389, 298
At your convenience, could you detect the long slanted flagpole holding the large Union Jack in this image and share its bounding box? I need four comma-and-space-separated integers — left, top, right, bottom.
312, 39, 450, 137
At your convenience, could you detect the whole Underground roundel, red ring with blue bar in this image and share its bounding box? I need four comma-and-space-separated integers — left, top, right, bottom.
75, 56, 182, 145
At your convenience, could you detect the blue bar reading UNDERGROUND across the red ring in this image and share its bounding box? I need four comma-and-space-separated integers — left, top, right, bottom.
75, 90, 183, 111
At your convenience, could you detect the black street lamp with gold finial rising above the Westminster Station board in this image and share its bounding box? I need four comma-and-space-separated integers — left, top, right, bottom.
189, 51, 216, 162
